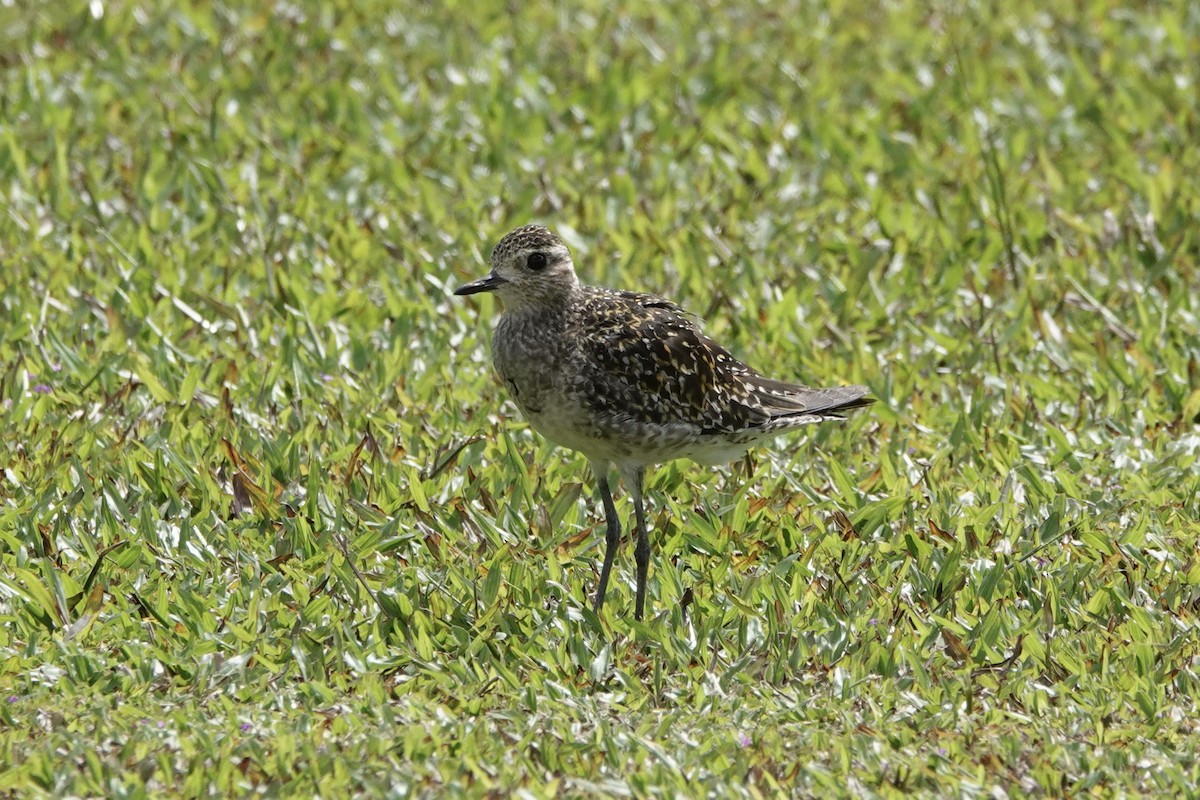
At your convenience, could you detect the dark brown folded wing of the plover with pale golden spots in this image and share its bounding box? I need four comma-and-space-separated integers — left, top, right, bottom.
581, 290, 770, 433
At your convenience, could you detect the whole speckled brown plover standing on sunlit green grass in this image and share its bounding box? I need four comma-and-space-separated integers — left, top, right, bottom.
455, 225, 875, 620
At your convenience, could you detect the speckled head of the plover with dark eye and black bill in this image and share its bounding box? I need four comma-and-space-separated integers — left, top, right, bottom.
455, 225, 580, 309
